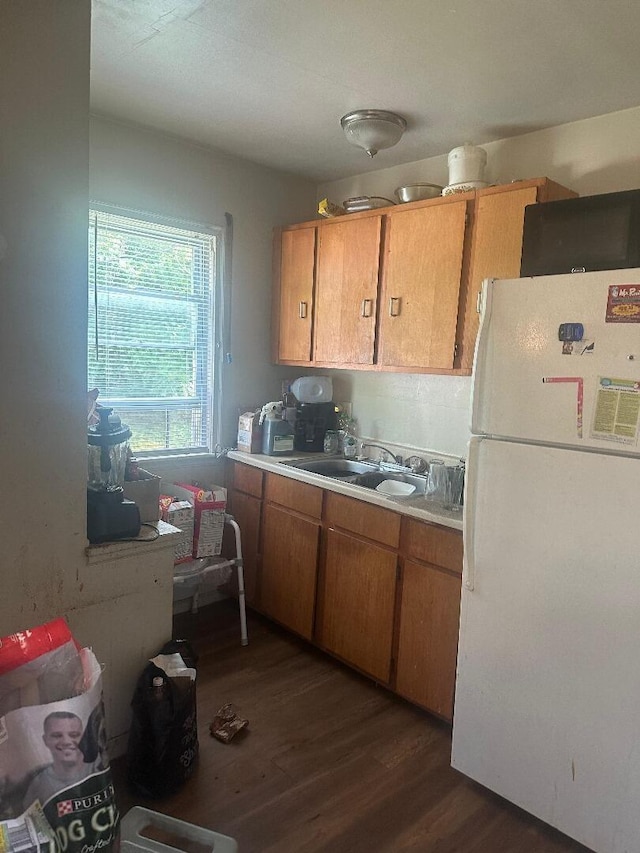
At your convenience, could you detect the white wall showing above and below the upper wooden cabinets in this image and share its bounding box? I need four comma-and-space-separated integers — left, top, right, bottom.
318, 107, 640, 456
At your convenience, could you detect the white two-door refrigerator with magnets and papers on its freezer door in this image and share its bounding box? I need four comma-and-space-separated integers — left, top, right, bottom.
452, 269, 640, 853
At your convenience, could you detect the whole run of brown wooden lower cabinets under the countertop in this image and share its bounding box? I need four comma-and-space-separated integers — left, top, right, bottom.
230, 463, 462, 720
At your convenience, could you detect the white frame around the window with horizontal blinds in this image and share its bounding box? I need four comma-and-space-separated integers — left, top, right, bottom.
87, 200, 222, 459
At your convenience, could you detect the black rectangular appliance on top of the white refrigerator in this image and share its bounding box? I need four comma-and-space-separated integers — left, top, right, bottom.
520, 189, 640, 277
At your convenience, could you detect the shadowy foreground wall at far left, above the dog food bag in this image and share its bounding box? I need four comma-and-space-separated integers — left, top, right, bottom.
0, 0, 90, 636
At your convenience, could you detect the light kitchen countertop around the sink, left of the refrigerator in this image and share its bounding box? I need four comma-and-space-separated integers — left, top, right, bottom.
227, 450, 462, 530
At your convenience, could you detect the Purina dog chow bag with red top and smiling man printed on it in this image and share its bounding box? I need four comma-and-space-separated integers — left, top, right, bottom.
0, 619, 119, 853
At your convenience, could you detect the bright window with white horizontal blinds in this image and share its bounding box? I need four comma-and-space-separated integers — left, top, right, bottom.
88, 210, 218, 452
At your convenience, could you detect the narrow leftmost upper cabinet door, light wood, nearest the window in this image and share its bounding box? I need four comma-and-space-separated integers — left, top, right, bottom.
278, 228, 316, 361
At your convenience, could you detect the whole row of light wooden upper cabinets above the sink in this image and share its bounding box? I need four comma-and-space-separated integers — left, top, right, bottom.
273, 178, 576, 374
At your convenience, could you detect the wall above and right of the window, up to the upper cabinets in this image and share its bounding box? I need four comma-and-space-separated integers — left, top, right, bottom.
90, 118, 315, 447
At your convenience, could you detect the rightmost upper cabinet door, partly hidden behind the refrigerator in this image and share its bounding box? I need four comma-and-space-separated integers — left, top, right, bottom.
456, 186, 538, 369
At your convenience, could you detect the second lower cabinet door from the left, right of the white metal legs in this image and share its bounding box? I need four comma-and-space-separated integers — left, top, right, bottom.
260, 503, 320, 640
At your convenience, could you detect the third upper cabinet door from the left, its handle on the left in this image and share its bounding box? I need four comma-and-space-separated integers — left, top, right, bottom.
378, 201, 467, 369
